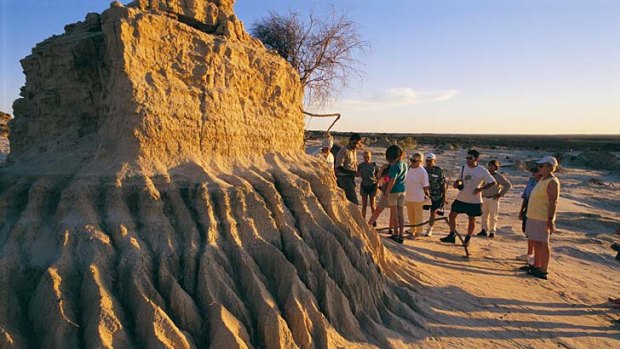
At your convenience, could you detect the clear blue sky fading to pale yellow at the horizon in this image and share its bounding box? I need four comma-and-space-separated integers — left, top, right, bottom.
0, 0, 620, 135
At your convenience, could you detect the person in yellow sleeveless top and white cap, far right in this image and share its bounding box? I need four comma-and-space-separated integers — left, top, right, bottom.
523, 155, 560, 280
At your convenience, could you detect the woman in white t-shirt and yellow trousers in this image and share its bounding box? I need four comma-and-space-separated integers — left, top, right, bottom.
405, 153, 430, 238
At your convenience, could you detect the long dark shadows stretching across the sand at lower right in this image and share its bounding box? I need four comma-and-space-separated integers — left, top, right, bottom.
386, 235, 620, 347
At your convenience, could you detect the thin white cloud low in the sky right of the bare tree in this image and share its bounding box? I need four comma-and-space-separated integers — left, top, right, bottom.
331, 87, 460, 112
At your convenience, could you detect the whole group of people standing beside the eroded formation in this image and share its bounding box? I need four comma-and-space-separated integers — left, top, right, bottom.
317, 133, 560, 279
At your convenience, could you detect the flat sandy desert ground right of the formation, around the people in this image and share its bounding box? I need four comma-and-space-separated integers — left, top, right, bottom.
306, 140, 620, 348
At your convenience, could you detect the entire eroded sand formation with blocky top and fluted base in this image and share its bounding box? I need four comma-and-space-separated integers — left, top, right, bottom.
0, 0, 423, 348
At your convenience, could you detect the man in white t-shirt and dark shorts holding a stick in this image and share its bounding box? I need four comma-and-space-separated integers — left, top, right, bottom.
440, 149, 496, 246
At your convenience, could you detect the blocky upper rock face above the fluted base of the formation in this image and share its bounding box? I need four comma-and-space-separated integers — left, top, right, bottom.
11, 1, 303, 174
